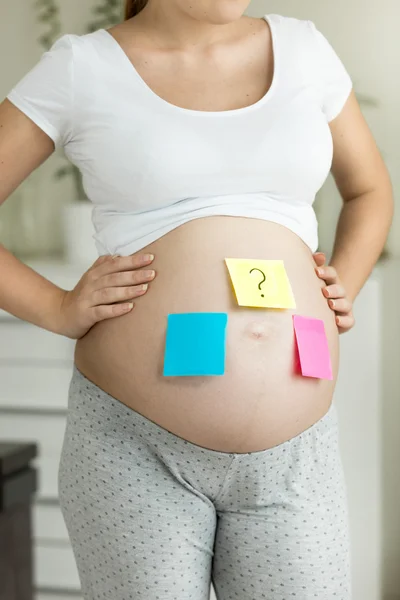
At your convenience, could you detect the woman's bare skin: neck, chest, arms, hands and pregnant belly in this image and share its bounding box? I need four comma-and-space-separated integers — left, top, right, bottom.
0, 0, 393, 452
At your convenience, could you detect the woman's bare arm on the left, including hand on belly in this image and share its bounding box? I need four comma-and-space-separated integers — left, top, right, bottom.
0, 100, 154, 339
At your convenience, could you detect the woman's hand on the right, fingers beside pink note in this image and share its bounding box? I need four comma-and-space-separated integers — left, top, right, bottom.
313, 252, 355, 333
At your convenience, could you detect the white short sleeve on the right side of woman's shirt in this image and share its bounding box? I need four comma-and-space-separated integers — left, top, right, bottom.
307, 21, 352, 122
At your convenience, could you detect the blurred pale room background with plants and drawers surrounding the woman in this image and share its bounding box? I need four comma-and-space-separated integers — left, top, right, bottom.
0, 0, 400, 600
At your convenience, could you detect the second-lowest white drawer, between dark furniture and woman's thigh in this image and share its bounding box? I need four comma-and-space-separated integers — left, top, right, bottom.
32, 502, 69, 544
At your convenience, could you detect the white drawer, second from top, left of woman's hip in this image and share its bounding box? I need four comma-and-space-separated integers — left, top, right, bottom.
0, 362, 73, 412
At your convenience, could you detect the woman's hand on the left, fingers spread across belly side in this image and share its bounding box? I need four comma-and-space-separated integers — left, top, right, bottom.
59, 254, 155, 339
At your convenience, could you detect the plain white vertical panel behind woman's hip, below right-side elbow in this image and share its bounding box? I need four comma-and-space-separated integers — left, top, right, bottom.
335, 268, 383, 600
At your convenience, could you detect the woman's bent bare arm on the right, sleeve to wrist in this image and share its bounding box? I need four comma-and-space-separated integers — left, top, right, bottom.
330, 92, 394, 302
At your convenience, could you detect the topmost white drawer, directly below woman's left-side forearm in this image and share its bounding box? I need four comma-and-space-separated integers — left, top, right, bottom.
0, 319, 75, 364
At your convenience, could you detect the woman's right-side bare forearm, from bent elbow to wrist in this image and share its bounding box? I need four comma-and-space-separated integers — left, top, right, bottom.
330, 184, 393, 301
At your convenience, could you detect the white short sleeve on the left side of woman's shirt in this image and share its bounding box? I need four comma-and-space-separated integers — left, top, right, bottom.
7, 34, 74, 148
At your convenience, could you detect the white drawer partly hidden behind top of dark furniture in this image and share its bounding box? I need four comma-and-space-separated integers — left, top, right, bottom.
0, 412, 66, 499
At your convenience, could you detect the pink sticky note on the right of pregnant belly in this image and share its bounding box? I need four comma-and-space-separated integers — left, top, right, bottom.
293, 315, 333, 379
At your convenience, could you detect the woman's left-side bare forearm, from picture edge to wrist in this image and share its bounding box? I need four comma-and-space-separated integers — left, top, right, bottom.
0, 244, 65, 333
